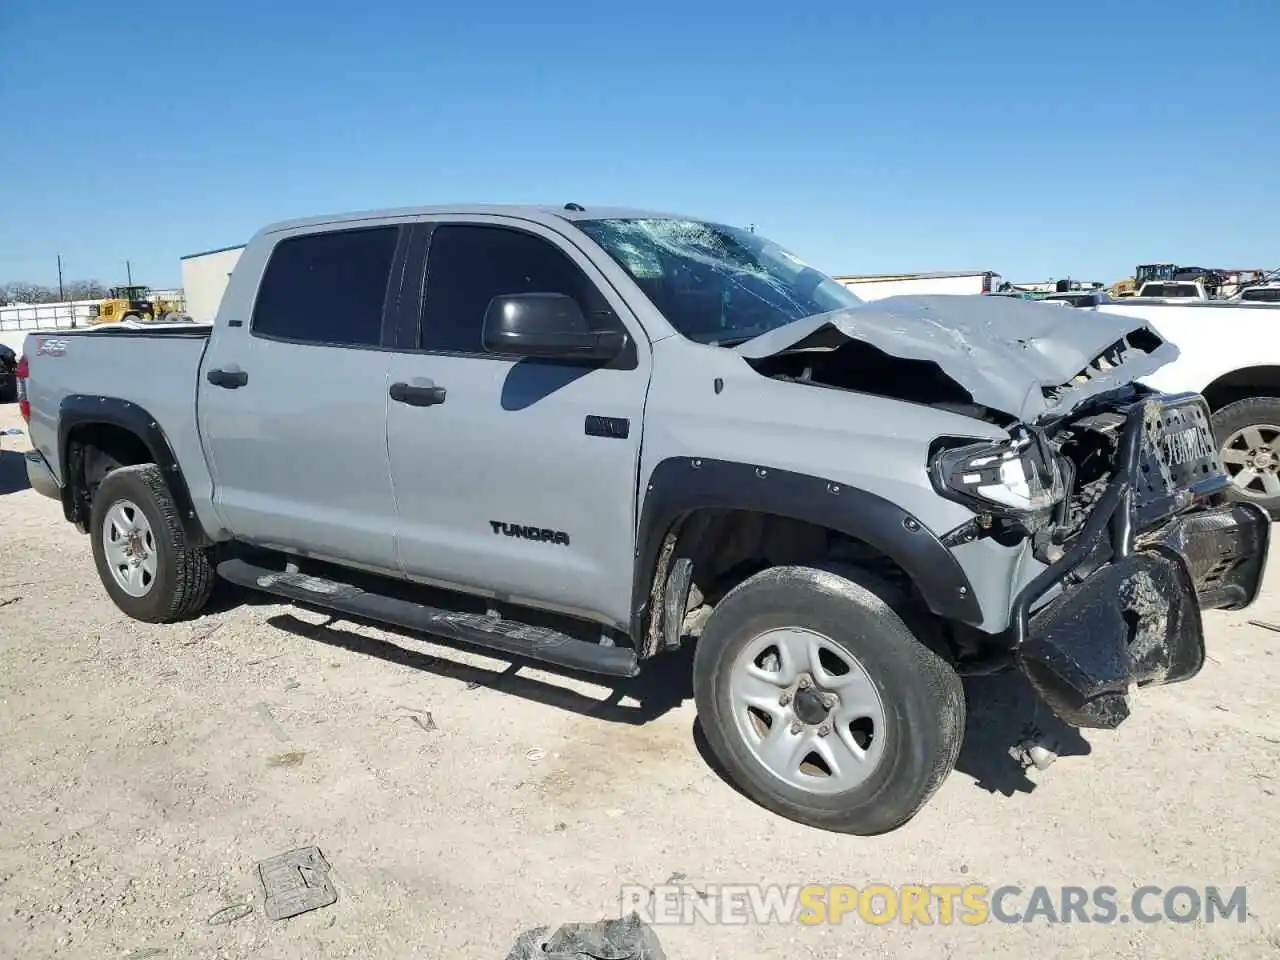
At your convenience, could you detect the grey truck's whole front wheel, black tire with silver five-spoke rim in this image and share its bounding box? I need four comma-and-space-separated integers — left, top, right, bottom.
694, 567, 965, 835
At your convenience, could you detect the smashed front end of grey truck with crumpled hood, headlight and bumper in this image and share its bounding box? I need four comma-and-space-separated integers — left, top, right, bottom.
737, 296, 1271, 728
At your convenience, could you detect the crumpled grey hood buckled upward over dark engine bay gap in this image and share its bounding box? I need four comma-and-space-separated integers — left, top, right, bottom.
733, 296, 1178, 424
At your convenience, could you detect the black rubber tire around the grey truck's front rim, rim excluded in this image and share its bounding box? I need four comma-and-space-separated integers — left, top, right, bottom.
694, 566, 965, 836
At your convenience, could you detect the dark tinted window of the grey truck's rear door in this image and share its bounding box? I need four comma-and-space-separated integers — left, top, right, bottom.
252, 227, 399, 347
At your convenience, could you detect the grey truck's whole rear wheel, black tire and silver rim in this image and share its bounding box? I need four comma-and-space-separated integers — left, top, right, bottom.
90, 463, 216, 623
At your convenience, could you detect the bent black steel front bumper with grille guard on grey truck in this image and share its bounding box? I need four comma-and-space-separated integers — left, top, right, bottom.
1012, 396, 1271, 728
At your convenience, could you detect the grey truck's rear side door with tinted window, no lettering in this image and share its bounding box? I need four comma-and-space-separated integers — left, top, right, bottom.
200, 224, 410, 573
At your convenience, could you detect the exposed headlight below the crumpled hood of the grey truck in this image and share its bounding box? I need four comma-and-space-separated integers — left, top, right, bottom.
929, 438, 1066, 513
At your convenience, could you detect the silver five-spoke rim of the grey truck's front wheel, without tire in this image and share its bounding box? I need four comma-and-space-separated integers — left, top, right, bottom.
730, 627, 886, 794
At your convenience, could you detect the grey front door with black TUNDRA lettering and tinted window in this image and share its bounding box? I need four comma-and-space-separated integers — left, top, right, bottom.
387, 218, 650, 625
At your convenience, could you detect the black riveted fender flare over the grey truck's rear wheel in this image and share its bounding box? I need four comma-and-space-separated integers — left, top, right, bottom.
58, 394, 210, 545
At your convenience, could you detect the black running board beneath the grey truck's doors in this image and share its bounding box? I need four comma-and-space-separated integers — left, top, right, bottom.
218, 559, 640, 677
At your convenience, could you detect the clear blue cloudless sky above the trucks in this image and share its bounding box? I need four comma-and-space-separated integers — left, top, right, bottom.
0, 0, 1280, 285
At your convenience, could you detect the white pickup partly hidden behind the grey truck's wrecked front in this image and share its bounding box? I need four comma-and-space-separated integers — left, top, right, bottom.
1080, 297, 1280, 517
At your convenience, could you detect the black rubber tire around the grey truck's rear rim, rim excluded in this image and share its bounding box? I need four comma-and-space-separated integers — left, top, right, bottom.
90, 463, 218, 623
